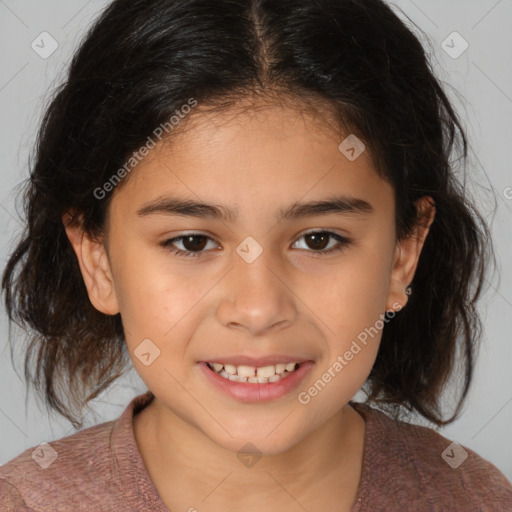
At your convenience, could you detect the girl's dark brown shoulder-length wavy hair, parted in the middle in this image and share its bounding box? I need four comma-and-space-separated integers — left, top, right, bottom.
2, 0, 493, 426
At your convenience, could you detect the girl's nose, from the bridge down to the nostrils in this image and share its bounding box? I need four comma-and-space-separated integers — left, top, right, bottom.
217, 243, 297, 336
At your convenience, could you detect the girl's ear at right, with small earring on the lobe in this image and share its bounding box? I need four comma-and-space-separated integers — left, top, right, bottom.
386, 196, 436, 311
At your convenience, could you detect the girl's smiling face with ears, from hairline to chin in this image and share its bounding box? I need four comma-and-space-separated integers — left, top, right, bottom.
63, 99, 432, 454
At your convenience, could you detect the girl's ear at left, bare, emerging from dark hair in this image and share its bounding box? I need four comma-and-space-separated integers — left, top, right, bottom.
62, 213, 119, 315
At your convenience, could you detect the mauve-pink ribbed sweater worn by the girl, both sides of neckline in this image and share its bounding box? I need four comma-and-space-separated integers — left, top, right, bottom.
0, 391, 512, 512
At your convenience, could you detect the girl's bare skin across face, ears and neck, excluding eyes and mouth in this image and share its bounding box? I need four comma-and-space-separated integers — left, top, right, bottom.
64, 97, 435, 512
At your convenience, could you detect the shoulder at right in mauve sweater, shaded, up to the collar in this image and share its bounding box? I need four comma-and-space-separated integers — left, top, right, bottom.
353, 404, 512, 512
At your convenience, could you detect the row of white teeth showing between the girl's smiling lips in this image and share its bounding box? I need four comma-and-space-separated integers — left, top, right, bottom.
206, 363, 301, 384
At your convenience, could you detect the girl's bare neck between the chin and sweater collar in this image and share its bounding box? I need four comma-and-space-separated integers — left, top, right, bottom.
134, 397, 365, 511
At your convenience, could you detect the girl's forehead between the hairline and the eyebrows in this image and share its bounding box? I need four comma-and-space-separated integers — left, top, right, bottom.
108, 100, 392, 220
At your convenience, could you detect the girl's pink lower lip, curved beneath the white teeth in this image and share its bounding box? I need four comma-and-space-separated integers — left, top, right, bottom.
198, 361, 314, 402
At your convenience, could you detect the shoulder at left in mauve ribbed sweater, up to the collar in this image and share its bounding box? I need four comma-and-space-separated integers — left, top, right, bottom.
0, 393, 154, 512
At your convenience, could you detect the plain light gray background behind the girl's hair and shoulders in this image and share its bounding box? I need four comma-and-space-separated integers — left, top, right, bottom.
0, 0, 512, 480
